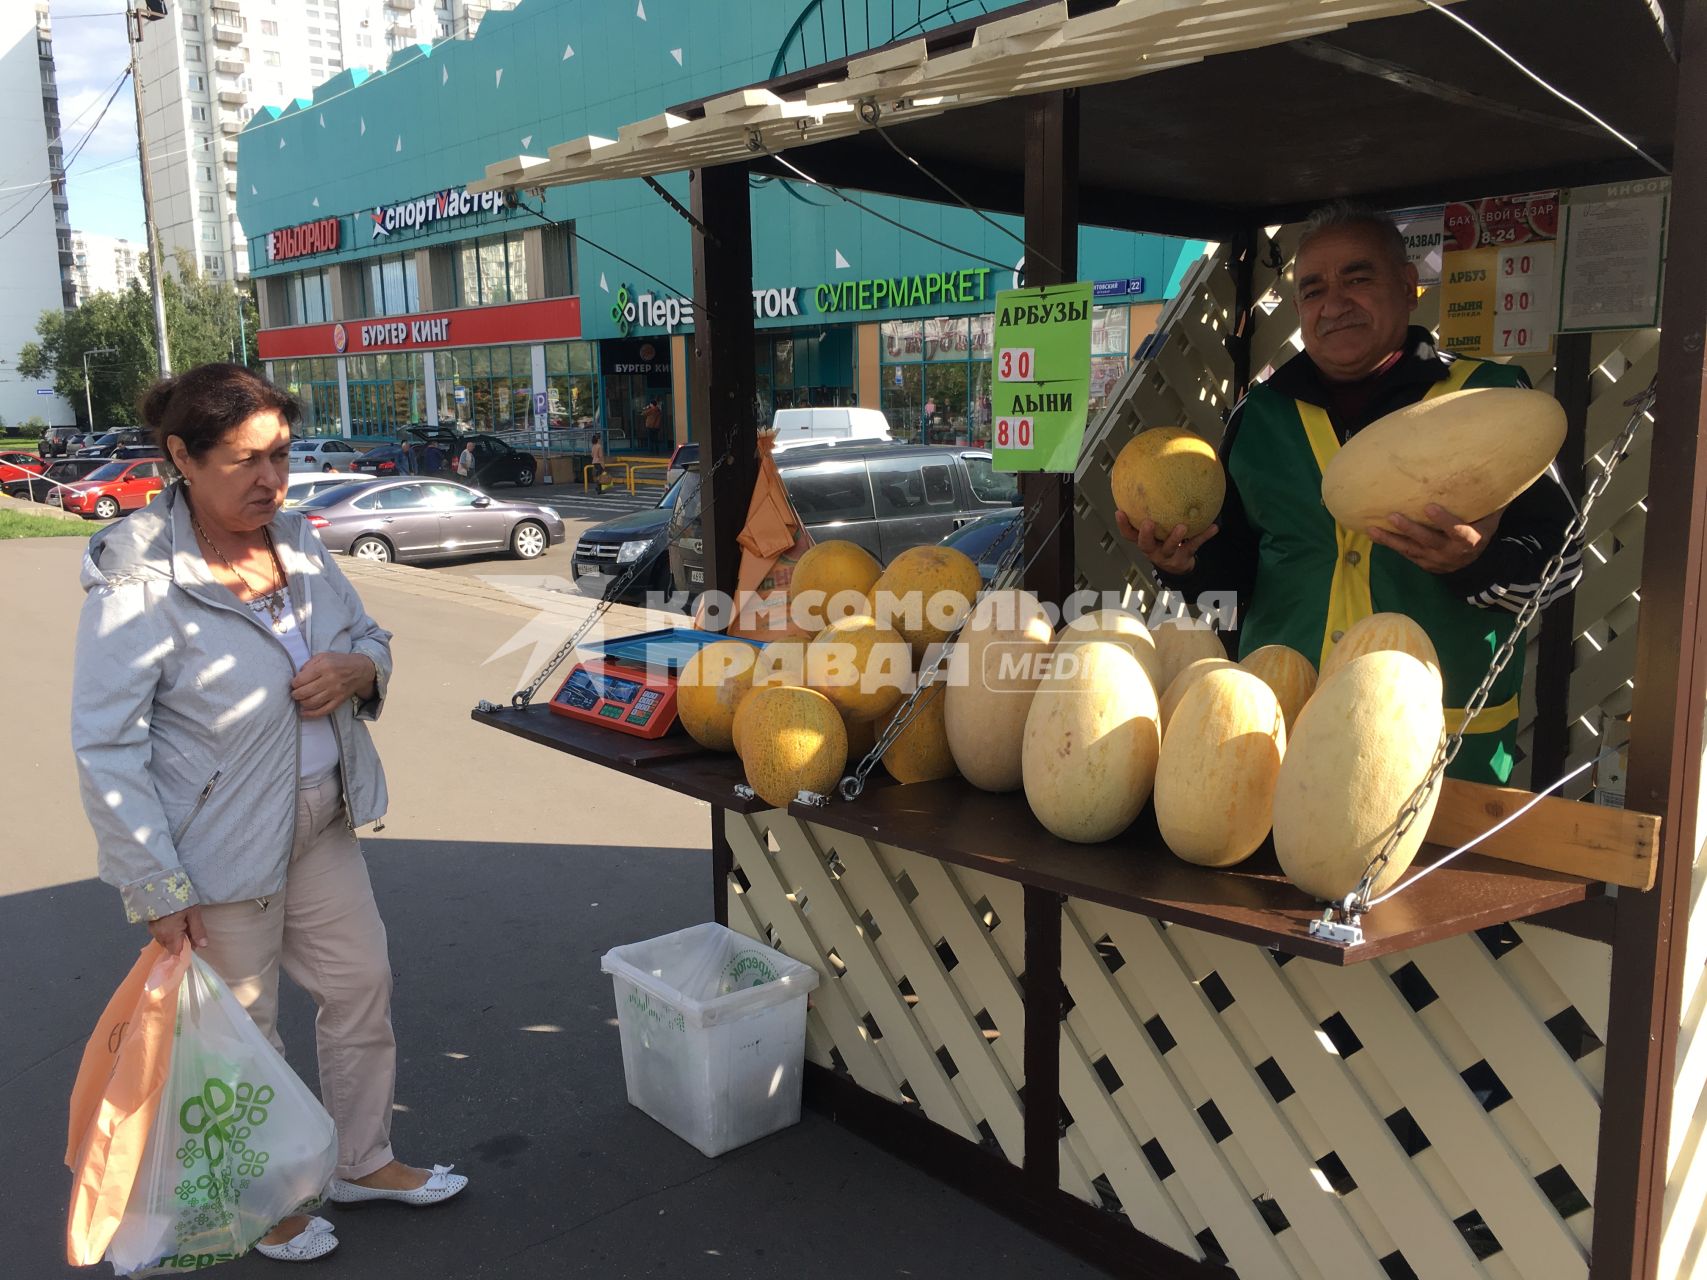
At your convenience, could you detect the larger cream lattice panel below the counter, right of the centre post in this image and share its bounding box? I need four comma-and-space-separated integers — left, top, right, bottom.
1062, 899, 1610, 1280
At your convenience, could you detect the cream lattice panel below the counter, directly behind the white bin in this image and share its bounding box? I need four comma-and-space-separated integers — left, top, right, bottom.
727, 811, 1024, 1191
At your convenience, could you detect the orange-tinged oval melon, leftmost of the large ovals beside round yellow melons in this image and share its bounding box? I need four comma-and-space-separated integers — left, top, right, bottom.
942, 591, 1050, 792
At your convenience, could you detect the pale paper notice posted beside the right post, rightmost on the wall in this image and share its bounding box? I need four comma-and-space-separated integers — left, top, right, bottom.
1558, 177, 1671, 333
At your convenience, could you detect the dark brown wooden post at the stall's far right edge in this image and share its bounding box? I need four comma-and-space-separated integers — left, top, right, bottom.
1589, 0, 1707, 1280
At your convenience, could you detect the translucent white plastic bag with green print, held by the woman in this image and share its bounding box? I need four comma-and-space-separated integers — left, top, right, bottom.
108, 956, 338, 1275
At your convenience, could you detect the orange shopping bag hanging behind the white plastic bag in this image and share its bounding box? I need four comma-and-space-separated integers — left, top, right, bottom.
65, 942, 189, 1266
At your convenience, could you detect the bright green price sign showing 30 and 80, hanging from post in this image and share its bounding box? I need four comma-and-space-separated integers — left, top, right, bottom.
990, 280, 1092, 473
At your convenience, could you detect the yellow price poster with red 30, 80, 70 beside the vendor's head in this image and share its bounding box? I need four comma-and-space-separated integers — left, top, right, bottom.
1441, 191, 1558, 355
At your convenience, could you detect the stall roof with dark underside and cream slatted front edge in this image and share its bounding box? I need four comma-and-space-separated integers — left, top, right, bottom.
475, 0, 1676, 234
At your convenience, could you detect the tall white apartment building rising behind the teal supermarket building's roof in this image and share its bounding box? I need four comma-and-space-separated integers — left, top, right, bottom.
140, 0, 517, 280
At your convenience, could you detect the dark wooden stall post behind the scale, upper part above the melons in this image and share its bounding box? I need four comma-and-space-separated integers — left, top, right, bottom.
688, 164, 758, 614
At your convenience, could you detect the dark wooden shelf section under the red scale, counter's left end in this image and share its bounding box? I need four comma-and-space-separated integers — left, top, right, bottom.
469, 703, 770, 814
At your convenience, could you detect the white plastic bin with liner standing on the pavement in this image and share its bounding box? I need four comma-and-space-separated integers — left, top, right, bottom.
599, 923, 818, 1155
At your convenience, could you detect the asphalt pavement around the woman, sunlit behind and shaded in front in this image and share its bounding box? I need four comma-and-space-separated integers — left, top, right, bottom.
0, 539, 1094, 1280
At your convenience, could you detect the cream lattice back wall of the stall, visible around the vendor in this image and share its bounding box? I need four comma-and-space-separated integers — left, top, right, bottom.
1074, 225, 1659, 795
